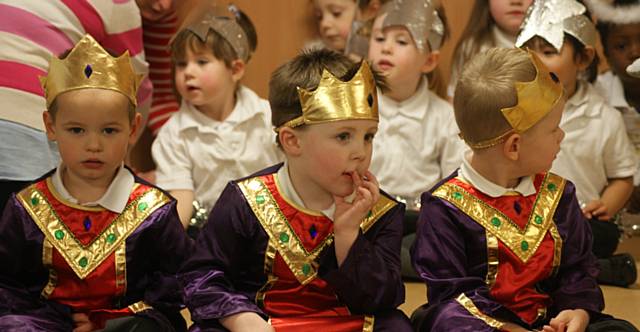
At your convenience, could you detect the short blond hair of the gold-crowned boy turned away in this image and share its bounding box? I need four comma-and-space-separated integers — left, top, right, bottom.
453, 48, 536, 148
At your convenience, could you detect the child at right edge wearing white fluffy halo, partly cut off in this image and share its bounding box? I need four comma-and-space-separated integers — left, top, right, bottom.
588, 0, 640, 213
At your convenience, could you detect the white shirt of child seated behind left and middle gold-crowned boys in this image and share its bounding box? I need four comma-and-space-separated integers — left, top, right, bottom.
152, 86, 282, 208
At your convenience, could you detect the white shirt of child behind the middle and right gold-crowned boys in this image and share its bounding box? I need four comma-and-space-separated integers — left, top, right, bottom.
370, 79, 465, 199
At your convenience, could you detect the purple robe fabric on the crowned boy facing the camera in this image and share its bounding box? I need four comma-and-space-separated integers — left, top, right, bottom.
0, 173, 192, 331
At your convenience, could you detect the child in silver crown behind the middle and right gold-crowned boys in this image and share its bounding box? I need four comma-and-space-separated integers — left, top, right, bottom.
369, 0, 464, 211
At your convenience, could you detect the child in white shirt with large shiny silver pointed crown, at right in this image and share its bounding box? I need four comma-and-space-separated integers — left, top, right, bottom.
516, 0, 638, 286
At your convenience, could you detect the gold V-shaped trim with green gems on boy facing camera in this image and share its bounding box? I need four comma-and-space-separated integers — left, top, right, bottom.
18, 185, 169, 279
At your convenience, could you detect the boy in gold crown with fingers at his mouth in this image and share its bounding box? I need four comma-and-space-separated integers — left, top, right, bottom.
179, 50, 411, 331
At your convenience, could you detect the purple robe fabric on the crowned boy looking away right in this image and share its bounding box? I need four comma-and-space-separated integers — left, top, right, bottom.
411, 172, 604, 331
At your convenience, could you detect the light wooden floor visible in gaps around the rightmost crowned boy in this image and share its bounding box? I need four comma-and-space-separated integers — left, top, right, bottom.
400, 237, 640, 328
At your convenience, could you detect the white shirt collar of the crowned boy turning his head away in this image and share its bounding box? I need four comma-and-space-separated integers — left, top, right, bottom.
458, 151, 536, 198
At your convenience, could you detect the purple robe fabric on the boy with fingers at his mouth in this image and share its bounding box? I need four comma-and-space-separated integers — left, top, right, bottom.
178, 164, 411, 331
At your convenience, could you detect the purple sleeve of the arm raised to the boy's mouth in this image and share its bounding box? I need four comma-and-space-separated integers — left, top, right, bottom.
319, 204, 404, 314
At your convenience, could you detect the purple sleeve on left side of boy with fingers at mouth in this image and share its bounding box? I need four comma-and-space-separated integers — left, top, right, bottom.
178, 183, 267, 328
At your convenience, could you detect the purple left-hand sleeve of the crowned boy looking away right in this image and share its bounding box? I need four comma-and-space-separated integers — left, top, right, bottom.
411, 193, 509, 331
